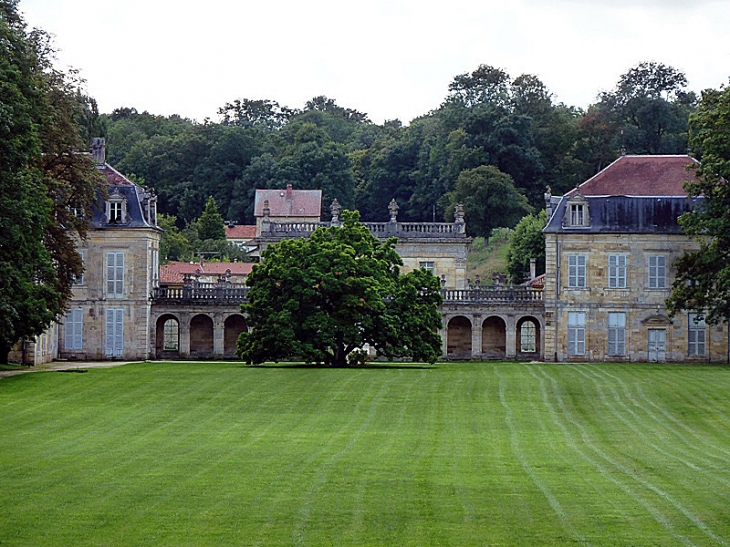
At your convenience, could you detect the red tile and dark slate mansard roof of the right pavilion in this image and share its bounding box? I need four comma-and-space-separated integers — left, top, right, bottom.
544, 156, 701, 234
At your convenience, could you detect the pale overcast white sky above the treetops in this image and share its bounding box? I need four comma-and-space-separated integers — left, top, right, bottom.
19, 0, 730, 124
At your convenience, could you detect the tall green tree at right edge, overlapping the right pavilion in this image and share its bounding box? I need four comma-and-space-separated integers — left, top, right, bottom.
667, 87, 730, 324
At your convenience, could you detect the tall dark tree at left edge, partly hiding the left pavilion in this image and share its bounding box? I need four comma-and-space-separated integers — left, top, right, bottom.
0, 0, 101, 362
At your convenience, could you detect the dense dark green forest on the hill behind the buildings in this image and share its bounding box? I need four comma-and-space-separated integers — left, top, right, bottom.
96, 62, 697, 236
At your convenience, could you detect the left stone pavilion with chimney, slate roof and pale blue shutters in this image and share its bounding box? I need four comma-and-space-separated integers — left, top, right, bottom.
58, 139, 162, 360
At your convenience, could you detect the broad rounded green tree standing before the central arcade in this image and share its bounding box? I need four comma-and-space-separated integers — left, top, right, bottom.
238, 211, 441, 366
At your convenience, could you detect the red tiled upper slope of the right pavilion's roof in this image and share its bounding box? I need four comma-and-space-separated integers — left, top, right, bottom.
567, 156, 697, 196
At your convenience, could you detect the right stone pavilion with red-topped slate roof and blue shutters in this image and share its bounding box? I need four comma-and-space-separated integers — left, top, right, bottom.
544, 156, 728, 362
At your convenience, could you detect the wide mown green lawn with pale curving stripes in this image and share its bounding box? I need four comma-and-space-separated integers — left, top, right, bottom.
0, 363, 730, 547
